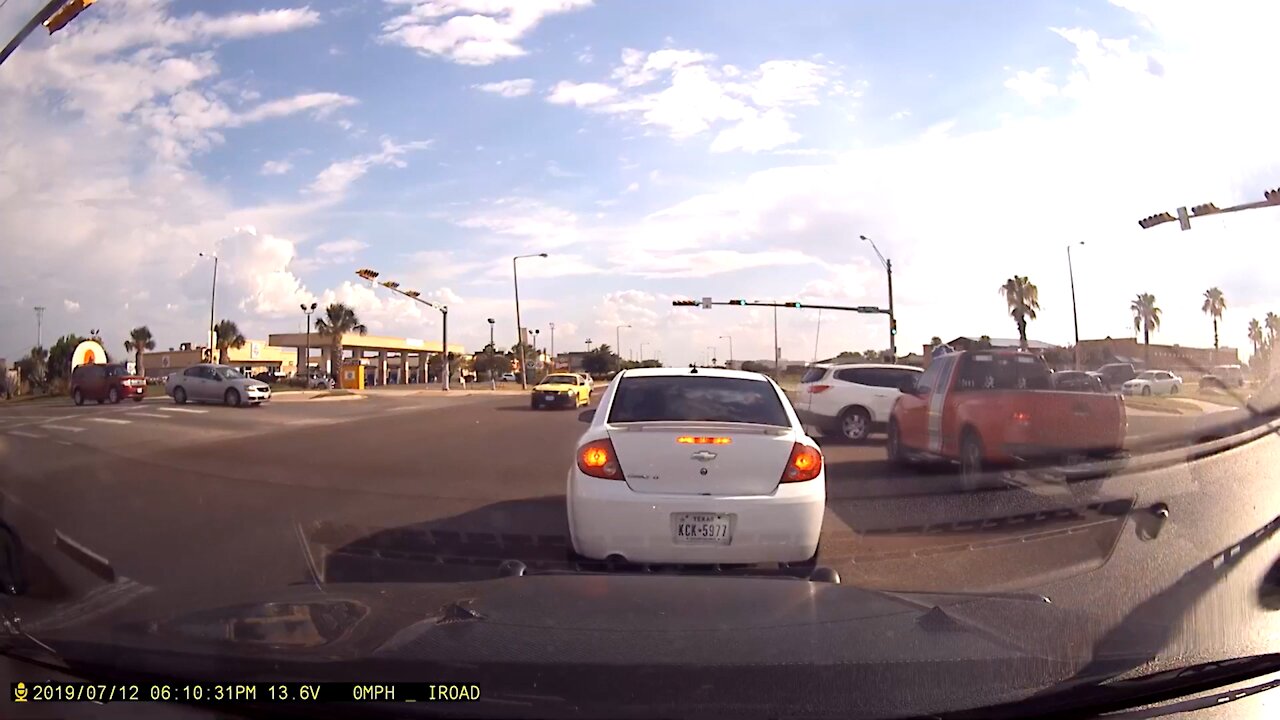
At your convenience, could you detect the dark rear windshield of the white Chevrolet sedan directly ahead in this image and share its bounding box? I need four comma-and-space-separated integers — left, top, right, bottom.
609, 375, 791, 428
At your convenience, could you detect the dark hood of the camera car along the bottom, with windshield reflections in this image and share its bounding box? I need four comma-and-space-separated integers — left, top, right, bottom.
12, 574, 1085, 717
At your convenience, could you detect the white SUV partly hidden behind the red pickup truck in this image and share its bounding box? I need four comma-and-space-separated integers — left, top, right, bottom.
795, 365, 923, 442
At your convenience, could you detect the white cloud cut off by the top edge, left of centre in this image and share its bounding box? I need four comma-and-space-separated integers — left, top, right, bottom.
381, 0, 591, 65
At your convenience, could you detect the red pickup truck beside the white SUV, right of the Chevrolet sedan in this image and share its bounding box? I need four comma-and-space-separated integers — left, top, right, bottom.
888, 350, 1128, 477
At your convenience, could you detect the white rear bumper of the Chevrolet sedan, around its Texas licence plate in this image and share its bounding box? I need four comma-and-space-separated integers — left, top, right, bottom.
566, 469, 827, 564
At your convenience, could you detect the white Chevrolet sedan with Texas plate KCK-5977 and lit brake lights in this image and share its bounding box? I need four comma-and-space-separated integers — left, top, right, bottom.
566, 368, 827, 564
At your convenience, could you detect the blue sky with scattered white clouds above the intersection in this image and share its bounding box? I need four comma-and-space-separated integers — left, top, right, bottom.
0, 0, 1280, 364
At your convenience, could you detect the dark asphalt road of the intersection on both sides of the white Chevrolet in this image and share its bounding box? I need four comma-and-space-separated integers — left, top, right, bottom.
0, 389, 1264, 602
